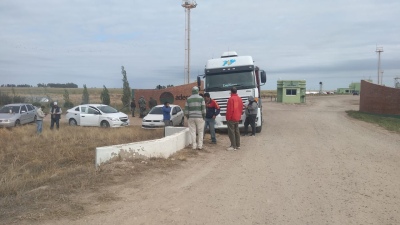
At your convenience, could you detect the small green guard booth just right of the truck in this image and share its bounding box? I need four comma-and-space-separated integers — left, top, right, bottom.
276, 80, 306, 103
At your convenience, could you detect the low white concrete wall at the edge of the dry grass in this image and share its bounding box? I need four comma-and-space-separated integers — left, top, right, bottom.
96, 127, 192, 166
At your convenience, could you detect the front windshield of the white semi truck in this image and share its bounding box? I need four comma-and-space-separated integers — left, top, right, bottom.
205, 71, 255, 91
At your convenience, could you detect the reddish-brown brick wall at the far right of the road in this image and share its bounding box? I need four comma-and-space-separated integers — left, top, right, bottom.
360, 80, 400, 115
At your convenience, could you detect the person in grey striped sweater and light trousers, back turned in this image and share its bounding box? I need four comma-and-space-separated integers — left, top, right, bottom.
185, 86, 206, 150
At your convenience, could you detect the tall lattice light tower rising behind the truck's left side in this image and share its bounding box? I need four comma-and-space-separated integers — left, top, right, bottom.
182, 0, 197, 84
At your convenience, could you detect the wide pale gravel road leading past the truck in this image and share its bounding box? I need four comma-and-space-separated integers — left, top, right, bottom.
42, 96, 400, 225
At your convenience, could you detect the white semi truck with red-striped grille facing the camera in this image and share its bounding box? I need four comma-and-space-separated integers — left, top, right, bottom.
197, 51, 267, 133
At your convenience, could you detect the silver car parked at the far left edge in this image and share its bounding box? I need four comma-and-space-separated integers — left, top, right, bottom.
0, 103, 36, 127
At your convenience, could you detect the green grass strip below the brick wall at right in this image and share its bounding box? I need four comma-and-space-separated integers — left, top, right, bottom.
346, 110, 400, 133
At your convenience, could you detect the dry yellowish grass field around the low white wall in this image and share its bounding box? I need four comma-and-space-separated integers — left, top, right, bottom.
0, 122, 202, 224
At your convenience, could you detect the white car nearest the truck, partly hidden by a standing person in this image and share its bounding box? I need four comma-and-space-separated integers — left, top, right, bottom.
142, 104, 185, 128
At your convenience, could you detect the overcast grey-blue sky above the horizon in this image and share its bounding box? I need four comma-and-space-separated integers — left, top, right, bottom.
0, 0, 400, 90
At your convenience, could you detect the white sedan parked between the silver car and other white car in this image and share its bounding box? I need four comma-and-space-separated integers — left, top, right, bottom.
65, 104, 129, 127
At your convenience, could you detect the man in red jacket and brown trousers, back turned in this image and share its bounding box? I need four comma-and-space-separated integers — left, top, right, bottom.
226, 87, 243, 151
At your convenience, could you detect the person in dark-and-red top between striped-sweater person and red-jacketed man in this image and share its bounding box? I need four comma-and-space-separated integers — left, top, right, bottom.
204, 93, 220, 144
